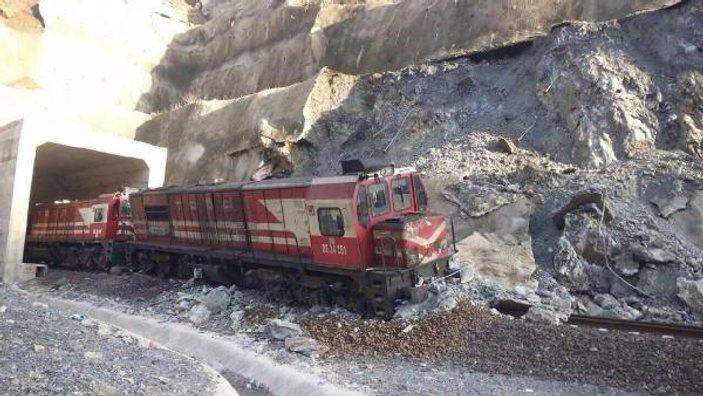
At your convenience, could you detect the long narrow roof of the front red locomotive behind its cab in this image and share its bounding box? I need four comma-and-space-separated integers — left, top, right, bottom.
138, 175, 359, 194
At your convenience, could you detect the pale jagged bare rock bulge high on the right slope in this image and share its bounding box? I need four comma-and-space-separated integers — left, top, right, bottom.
540, 36, 659, 167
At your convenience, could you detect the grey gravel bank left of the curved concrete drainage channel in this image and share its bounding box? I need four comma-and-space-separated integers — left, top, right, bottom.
0, 284, 215, 395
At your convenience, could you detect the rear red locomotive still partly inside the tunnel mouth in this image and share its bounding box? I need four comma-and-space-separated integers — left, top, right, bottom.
25, 194, 134, 268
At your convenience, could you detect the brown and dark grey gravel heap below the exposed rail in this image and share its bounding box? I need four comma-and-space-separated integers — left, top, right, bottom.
303, 302, 703, 395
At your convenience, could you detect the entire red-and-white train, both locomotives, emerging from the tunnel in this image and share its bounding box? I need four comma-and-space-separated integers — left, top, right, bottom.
26, 160, 454, 317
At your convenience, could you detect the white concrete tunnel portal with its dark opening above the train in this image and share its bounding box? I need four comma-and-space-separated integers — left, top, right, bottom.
0, 118, 166, 282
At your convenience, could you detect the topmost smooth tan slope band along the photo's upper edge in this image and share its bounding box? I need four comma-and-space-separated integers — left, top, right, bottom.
140, 0, 677, 112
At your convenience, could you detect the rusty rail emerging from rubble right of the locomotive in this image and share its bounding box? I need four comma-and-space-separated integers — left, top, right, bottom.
494, 301, 703, 340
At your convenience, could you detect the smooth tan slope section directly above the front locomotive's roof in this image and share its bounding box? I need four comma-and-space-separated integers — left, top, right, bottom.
137, 80, 315, 184
